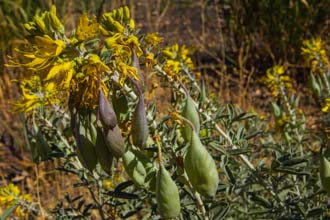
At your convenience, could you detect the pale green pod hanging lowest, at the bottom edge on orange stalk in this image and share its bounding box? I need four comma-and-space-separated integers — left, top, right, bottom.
156, 164, 181, 219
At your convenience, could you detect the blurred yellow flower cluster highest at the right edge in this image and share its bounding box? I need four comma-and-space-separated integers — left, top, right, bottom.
301, 38, 330, 74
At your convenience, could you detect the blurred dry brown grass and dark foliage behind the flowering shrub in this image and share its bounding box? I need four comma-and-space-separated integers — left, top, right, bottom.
0, 0, 330, 217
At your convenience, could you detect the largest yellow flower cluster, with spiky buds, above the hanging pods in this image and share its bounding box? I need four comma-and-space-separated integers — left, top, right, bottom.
7, 6, 144, 112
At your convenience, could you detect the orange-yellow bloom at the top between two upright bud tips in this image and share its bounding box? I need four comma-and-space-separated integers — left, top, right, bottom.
76, 14, 99, 41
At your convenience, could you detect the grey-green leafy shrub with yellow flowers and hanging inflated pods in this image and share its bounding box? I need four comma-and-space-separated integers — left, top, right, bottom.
0, 6, 330, 219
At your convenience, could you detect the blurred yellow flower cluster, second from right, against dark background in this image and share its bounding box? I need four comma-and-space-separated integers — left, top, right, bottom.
261, 65, 292, 97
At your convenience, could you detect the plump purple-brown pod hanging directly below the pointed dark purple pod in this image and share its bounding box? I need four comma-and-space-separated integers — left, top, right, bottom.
105, 125, 125, 158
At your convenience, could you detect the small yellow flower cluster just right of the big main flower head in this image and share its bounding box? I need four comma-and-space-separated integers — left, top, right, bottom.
163, 44, 194, 78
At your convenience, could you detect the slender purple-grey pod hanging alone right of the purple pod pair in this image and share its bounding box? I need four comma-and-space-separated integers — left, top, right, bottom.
131, 95, 149, 149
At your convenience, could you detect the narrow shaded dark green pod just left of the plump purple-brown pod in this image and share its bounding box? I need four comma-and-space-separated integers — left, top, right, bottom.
95, 128, 113, 175
